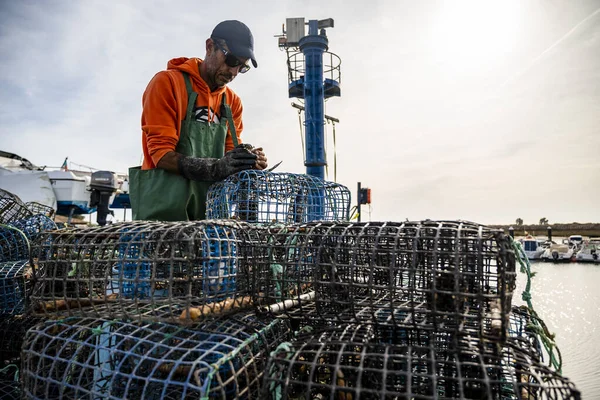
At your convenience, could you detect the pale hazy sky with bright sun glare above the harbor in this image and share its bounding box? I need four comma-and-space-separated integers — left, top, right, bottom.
0, 0, 600, 224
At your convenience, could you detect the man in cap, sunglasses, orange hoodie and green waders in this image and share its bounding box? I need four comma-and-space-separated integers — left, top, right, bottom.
129, 21, 267, 221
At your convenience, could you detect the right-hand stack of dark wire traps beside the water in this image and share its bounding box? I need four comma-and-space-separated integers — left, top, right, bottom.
251, 220, 579, 399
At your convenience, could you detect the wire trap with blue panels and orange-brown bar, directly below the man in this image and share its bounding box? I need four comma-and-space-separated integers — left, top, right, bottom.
31, 221, 251, 322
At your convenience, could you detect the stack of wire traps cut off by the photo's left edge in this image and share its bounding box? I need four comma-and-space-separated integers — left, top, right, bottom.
0, 189, 56, 399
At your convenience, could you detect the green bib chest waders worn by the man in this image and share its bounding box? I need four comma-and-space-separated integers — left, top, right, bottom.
129, 72, 238, 221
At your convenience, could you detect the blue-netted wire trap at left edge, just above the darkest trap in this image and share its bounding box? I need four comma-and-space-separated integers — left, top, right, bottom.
0, 260, 32, 315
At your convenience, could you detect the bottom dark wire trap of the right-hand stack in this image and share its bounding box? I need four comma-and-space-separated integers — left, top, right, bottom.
261, 334, 580, 400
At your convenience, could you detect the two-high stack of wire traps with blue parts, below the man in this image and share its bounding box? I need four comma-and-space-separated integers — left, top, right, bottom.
22, 221, 290, 399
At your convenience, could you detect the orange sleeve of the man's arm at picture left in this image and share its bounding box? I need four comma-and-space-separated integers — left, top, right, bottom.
142, 71, 180, 169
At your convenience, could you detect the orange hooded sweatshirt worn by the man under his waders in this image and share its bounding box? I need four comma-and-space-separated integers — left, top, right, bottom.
142, 57, 243, 169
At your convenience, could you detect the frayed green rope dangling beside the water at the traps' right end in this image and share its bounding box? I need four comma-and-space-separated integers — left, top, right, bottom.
511, 238, 562, 374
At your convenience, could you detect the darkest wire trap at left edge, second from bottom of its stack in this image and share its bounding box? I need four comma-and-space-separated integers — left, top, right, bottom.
0, 315, 43, 366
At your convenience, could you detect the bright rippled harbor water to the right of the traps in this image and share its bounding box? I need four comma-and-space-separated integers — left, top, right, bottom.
513, 262, 600, 400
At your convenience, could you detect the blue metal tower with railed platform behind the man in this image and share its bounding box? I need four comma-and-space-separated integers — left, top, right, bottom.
279, 18, 341, 179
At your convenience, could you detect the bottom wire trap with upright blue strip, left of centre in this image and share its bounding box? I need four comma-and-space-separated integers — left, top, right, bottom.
22, 313, 290, 400
